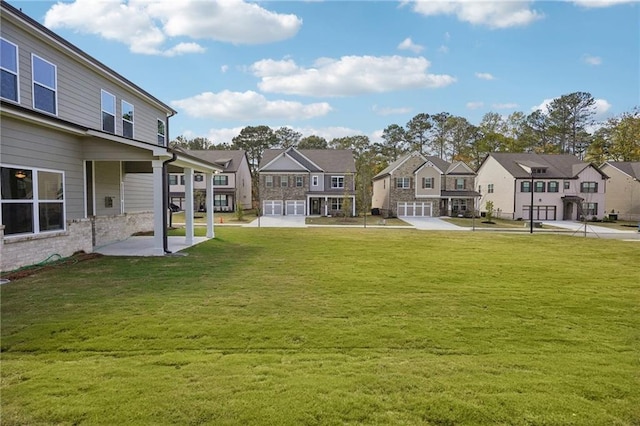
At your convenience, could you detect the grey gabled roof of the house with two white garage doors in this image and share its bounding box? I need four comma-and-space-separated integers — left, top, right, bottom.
258, 148, 356, 173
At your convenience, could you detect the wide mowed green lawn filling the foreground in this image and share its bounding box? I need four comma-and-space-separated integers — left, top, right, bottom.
0, 231, 640, 425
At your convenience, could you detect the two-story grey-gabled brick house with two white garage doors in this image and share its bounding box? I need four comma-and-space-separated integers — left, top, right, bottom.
258, 148, 356, 216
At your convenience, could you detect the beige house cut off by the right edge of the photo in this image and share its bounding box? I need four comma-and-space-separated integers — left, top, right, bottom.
600, 161, 640, 221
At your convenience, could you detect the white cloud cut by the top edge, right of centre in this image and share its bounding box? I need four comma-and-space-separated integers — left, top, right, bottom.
403, 0, 543, 29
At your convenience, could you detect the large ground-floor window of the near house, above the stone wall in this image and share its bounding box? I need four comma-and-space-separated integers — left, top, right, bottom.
0, 166, 65, 235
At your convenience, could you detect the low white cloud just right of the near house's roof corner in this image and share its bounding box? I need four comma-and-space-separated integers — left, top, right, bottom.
171, 90, 331, 121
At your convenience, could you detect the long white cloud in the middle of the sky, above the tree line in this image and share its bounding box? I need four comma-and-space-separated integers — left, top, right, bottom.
250, 56, 456, 96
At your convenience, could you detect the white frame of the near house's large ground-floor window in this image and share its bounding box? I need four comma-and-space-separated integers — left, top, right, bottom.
0, 164, 67, 238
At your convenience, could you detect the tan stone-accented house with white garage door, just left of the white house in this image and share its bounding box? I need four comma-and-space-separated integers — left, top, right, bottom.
371, 152, 480, 217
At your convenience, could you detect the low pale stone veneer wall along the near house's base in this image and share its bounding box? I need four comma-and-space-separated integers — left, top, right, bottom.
0, 212, 153, 271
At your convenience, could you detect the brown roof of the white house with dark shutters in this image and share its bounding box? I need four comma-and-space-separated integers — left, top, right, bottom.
478, 152, 606, 179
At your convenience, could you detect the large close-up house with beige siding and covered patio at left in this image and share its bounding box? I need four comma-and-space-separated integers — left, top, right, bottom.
0, 1, 221, 271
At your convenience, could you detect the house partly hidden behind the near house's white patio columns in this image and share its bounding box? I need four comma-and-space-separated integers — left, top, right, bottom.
169, 150, 252, 212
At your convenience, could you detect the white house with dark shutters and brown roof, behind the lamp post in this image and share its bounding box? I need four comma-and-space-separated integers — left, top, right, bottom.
476, 153, 607, 220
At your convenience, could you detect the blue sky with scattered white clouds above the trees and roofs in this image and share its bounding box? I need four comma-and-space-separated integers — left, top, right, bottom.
9, 0, 640, 143
